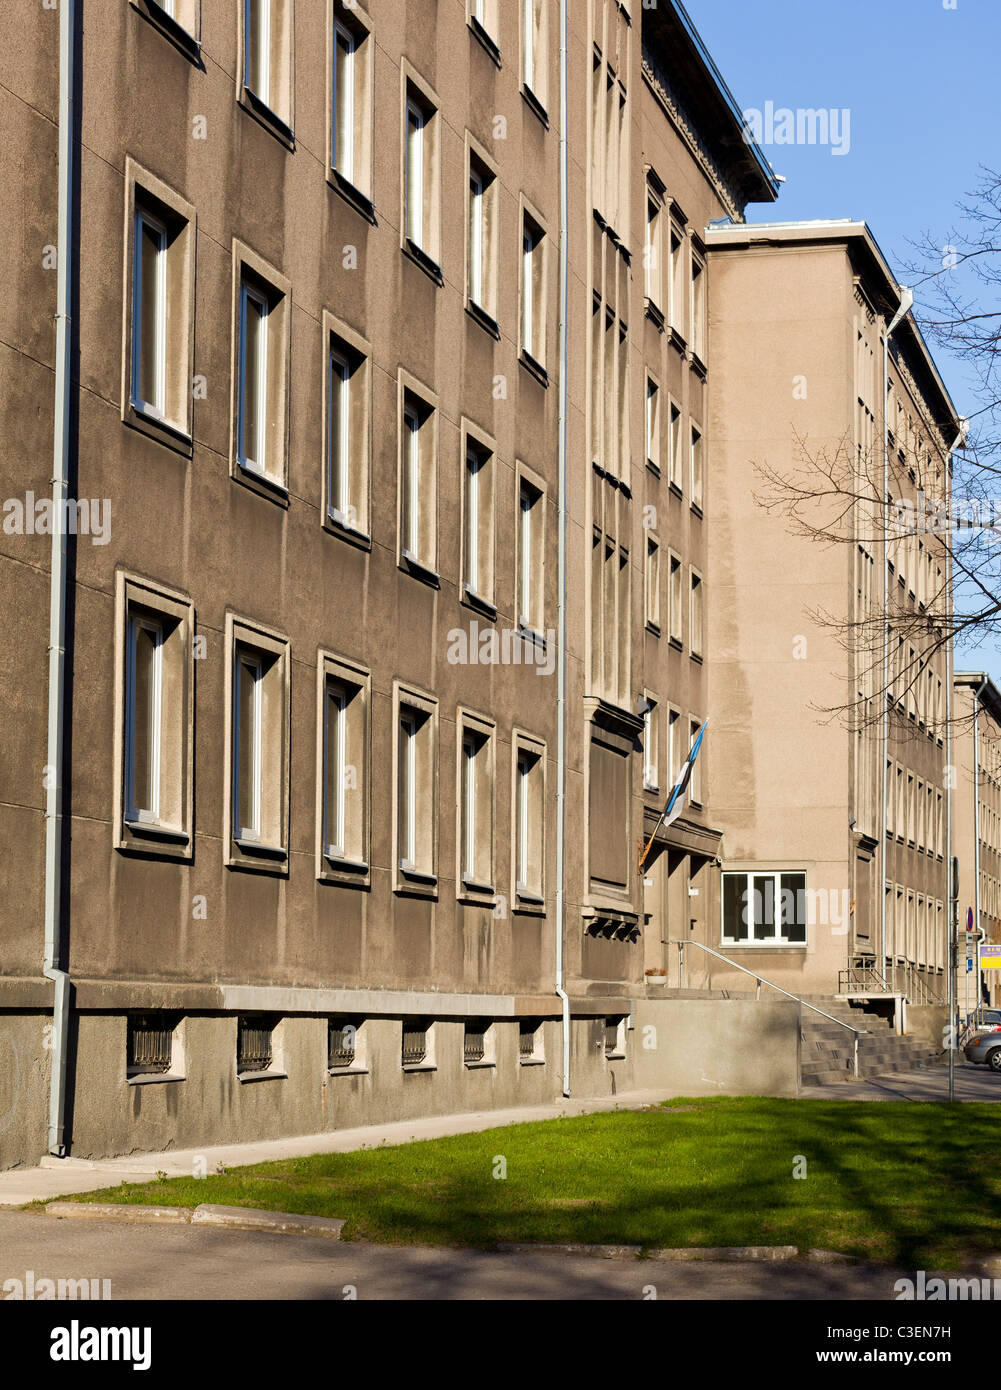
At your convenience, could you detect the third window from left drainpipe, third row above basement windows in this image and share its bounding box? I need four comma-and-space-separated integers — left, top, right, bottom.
329, 0, 373, 199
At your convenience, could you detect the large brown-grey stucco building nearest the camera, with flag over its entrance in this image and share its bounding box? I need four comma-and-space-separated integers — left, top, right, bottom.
0, 0, 776, 1166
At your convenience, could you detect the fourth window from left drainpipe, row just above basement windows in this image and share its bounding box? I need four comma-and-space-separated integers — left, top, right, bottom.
396, 688, 437, 890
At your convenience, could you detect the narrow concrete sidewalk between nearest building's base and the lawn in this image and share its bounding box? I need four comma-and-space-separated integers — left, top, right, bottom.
0, 1091, 674, 1207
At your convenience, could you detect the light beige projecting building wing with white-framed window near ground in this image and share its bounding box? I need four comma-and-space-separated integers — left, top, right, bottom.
708, 222, 959, 1023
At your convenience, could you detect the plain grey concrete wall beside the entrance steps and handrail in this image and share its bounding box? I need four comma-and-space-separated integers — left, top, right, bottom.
633, 999, 799, 1095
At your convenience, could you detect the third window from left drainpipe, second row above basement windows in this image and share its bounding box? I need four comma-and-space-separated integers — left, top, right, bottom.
325, 331, 371, 535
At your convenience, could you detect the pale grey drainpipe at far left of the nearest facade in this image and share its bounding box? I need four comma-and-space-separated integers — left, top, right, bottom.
42, 0, 76, 1158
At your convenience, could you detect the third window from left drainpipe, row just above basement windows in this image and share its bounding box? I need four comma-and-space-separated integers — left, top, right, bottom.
317, 653, 370, 884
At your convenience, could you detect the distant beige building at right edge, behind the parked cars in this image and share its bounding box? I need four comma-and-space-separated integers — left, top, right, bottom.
952, 671, 1001, 1009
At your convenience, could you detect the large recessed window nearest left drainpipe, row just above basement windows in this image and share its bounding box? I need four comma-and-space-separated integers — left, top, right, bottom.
117, 575, 193, 856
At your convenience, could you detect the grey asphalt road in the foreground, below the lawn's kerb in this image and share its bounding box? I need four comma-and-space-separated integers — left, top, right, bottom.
0, 1212, 900, 1301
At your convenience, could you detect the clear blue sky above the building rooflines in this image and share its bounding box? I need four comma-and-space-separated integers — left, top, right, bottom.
684, 0, 1001, 681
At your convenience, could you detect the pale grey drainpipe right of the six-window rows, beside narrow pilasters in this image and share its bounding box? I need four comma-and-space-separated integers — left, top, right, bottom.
556, 0, 570, 1095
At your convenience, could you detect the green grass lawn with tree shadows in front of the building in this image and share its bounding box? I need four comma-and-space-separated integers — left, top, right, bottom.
50, 1098, 1001, 1269
